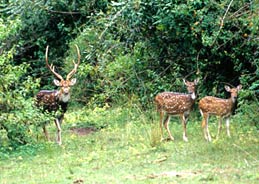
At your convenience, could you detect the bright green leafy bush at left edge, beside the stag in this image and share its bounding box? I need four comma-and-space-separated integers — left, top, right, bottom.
0, 50, 43, 147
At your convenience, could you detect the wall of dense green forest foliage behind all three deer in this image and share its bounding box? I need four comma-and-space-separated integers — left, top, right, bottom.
2, 0, 259, 106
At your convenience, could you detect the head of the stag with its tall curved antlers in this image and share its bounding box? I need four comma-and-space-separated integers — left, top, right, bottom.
46, 45, 81, 101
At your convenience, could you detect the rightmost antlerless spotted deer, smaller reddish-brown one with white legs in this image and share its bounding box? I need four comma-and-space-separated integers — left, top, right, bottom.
199, 85, 242, 141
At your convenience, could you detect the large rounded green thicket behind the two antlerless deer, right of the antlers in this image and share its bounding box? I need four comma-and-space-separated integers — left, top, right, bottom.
66, 1, 258, 105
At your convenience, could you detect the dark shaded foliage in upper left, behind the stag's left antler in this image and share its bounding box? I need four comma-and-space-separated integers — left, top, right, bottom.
0, 0, 106, 88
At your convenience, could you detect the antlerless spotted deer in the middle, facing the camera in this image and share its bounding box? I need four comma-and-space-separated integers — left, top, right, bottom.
155, 79, 198, 141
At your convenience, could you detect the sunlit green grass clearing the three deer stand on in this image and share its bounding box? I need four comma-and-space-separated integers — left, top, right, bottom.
0, 108, 259, 184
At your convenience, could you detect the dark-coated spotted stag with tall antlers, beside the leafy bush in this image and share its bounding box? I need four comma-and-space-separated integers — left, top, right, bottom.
36, 45, 81, 145
